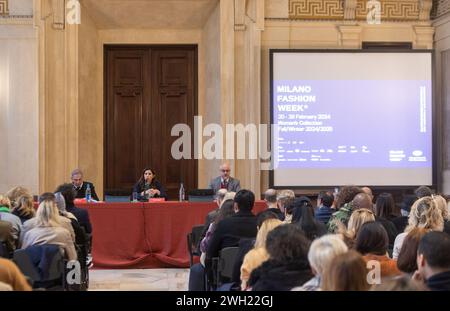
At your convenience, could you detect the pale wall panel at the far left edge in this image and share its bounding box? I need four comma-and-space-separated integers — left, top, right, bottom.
0, 24, 39, 194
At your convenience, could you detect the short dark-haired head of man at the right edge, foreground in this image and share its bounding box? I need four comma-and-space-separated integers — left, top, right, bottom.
417, 231, 450, 279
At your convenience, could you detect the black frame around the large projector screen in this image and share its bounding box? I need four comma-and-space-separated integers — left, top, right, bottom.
269, 48, 442, 191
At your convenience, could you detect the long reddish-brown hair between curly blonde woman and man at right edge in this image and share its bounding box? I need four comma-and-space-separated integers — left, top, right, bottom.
397, 228, 428, 276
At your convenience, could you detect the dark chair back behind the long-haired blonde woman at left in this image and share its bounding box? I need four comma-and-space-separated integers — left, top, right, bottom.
13, 245, 65, 283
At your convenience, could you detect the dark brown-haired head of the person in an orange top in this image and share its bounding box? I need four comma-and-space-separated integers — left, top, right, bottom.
355, 221, 389, 256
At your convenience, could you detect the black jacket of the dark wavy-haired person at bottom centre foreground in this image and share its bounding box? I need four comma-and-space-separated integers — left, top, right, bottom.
249, 259, 313, 291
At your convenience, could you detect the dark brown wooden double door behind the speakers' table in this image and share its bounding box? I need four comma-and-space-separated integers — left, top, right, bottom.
104, 46, 197, 199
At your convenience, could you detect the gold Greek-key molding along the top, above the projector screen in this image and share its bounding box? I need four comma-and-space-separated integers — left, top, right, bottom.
289, 0, 432, 21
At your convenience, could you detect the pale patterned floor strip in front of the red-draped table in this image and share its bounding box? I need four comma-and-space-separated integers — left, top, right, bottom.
89, 269, 189, 291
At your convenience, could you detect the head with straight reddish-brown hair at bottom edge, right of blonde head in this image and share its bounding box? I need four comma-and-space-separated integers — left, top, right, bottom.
321, 250, 370, 291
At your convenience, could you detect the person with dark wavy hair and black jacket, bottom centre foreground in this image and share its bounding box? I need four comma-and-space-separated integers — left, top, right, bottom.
248, 224, 313, 291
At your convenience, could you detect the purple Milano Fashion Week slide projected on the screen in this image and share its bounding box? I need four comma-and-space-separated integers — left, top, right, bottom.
273, 80, 432, 168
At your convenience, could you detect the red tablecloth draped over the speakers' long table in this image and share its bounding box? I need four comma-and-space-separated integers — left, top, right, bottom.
79, 201, 266, 269
